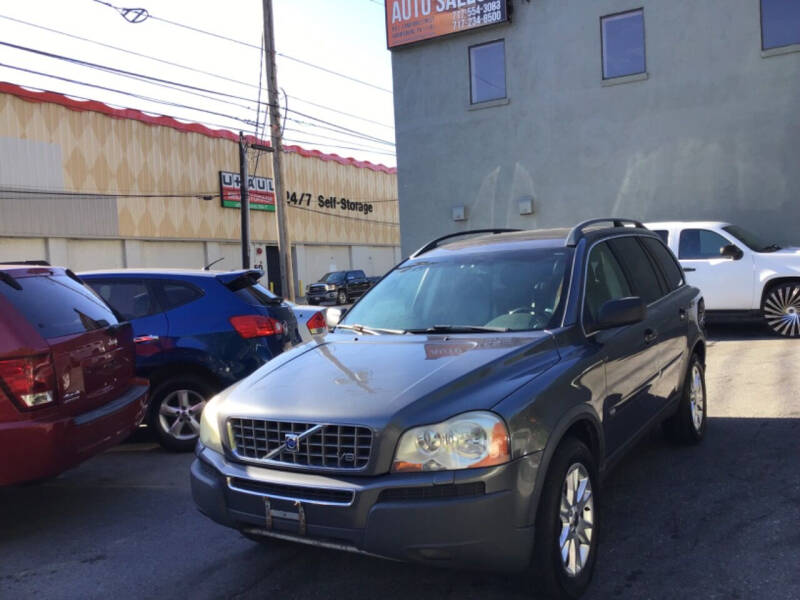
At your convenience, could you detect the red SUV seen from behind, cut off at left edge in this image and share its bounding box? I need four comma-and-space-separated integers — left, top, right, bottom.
0, 264, 147, 485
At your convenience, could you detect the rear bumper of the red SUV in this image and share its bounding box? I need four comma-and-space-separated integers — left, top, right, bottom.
0, 380, 148, 485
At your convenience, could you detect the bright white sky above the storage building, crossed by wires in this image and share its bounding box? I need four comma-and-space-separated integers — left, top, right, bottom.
0, 0, 396, 166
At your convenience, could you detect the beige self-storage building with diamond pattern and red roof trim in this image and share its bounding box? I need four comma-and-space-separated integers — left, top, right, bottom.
0, 83, 400, 298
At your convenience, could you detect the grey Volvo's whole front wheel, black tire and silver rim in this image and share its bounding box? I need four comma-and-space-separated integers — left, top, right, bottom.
532, 438, 600, 599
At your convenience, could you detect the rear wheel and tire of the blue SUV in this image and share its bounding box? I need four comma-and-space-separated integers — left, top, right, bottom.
147, 375, 215, 452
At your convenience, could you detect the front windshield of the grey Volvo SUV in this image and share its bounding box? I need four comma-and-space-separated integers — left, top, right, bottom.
342, 248, 572, 332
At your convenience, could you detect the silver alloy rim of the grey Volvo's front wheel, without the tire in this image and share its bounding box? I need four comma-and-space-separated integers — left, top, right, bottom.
557, 463, 594, 577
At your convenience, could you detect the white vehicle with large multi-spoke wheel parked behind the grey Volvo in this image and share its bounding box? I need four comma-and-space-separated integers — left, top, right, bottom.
646, 221, 800, 337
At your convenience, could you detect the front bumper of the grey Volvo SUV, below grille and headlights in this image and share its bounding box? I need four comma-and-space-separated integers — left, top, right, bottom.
191, 447, 540, 570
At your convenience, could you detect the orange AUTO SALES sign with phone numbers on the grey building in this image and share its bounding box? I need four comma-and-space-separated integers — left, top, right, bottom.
386, 0, 508, 48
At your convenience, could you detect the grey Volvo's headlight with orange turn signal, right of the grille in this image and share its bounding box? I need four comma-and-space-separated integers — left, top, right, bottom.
392, 411, 510, 473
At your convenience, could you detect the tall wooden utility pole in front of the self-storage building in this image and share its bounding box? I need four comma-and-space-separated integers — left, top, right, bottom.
263, 0, 294, 300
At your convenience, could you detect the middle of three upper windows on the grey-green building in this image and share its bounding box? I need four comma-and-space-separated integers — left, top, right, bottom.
600, 8, 645, 79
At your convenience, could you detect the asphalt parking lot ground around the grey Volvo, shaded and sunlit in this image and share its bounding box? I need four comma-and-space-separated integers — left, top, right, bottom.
0, 326, 800, 600
